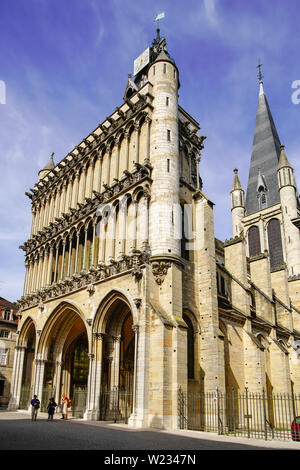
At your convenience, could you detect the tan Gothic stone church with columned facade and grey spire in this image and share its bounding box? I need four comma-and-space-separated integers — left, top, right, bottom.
9, 30, 300, 428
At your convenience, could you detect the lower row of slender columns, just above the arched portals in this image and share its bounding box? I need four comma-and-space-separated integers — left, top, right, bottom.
23, 192, 150, 296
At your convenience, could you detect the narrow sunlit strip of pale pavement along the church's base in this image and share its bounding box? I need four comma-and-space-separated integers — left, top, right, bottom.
0, 410, 300, 450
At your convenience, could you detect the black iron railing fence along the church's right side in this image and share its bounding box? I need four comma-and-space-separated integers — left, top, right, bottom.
178, 388, 300, 440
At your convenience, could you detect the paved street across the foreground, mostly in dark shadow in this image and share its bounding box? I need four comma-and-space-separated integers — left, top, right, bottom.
0, 411, 300, 451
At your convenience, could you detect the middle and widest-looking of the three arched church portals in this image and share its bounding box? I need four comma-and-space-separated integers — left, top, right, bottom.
35, 302, 89, 416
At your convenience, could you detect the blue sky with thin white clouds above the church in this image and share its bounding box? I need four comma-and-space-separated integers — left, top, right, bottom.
0, 0, 300, 301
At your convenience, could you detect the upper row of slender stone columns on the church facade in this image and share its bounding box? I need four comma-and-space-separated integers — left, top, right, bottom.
30, 115, 151, 237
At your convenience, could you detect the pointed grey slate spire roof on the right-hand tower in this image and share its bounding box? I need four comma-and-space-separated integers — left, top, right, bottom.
246, 81, 281, 215
